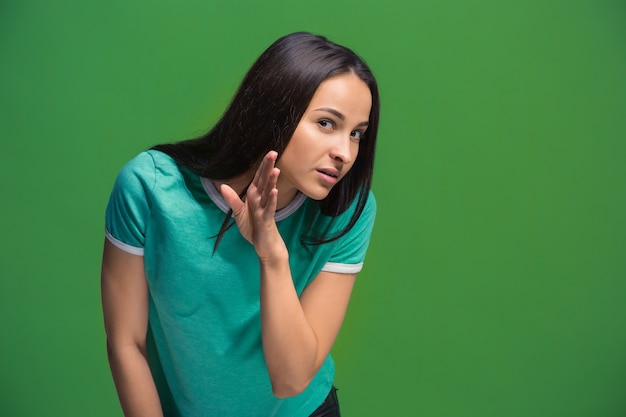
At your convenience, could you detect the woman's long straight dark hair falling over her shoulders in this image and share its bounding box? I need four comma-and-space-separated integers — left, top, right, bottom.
153, 32, 380, 245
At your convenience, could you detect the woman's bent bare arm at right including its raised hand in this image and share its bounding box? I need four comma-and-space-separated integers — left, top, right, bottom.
221, 152, 355, 397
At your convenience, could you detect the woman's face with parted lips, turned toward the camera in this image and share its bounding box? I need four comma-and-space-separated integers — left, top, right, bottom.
276, 72, 372, 208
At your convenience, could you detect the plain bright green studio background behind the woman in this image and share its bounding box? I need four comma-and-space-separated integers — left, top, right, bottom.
0, 0, 626, 417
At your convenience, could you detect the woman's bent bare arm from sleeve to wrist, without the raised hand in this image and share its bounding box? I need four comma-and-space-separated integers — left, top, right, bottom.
261, 264, 356, 397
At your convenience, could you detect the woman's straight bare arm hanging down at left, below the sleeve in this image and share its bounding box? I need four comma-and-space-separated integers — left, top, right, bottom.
101, 240, 163, 417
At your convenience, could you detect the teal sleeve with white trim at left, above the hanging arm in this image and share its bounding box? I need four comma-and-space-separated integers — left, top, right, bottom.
105, 152, 156, 255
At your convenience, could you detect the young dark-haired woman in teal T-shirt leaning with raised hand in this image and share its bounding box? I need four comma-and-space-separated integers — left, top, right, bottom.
102, 33, 379, 417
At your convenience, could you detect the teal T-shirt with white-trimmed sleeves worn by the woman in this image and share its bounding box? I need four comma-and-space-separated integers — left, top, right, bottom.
106, 151, 376, 417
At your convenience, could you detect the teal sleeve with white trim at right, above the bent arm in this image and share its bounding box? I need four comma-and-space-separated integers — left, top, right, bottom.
322, 191, 376, 274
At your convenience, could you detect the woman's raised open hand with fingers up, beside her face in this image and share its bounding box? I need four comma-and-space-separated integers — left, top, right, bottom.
220, 151, 287, 260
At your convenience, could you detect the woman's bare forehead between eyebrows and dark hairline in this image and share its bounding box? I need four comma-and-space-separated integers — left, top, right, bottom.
307, 72, 372, 118
